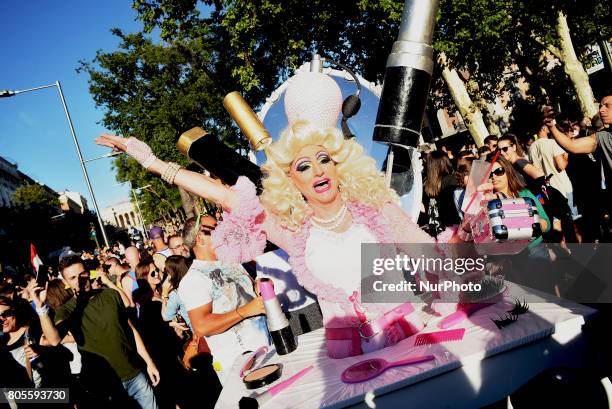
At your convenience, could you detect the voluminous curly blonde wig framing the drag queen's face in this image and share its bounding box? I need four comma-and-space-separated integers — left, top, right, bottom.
261, 121, 399, 231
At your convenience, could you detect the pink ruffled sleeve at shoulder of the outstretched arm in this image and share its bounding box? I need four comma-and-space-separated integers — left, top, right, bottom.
211, 176, 266, 263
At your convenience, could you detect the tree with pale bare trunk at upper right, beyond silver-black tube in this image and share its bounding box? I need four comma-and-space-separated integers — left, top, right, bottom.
434, 0, 612, 126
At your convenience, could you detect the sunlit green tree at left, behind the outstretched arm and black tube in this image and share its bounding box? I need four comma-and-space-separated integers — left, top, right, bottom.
79, 29, 239, 220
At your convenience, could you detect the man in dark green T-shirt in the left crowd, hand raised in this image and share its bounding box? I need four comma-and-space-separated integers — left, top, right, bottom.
34, 255, 159, 409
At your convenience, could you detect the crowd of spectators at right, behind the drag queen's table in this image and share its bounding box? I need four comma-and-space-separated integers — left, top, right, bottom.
419, 96, 612, 247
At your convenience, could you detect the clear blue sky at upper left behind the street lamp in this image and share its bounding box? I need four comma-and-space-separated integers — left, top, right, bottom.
0, 0, 147, 208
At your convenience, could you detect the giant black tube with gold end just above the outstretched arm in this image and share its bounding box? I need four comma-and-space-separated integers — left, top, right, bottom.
177, 127, 262, 192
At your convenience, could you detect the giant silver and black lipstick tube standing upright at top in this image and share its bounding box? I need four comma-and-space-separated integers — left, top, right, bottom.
373, 0, 439, 147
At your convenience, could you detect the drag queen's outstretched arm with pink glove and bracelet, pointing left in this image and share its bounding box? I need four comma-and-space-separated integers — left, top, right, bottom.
96, 134, 236, 209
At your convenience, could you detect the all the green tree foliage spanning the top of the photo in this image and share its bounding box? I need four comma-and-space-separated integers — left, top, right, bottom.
79, 0, 610, 191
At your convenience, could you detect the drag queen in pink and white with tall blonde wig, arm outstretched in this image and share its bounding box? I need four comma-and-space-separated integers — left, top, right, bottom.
96, 73, 450, 358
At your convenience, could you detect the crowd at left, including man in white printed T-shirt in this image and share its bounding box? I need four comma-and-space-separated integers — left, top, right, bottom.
0, 215, 253, 408
